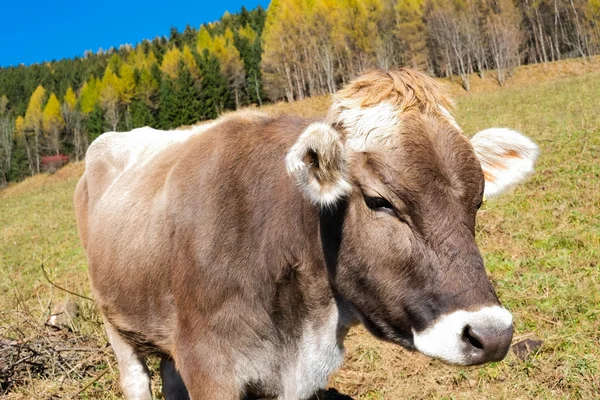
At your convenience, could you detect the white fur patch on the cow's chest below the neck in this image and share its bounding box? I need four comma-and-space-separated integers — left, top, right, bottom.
282, 303, 347, 400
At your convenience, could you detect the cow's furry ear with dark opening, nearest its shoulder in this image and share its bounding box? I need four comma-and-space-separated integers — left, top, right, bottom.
285, 123, 351, 207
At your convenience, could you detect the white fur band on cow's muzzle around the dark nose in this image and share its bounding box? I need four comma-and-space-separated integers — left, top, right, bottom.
413, 306, 512, 365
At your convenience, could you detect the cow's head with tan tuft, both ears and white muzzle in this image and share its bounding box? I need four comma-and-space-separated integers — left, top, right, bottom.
286, 70, 538, 365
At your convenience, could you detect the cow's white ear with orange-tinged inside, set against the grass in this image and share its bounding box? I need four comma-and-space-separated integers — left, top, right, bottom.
471, 128, 539, 198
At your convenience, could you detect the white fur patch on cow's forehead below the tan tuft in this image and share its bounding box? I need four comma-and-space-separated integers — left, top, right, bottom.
336, 103, 400, 152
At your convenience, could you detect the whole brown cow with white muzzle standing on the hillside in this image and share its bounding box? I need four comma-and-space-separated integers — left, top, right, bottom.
75, 69, 538, 400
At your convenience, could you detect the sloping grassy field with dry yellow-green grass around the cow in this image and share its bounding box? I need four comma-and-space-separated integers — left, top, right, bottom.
0, 60, 600, 399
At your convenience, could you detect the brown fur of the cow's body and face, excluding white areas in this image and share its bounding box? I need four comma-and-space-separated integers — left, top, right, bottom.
75, 70, 510, 399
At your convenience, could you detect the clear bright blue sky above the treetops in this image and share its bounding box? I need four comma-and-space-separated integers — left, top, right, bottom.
0, 0, 269, 67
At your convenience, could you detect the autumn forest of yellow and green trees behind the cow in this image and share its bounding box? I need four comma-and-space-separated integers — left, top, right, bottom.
0, 0, 600, 187
